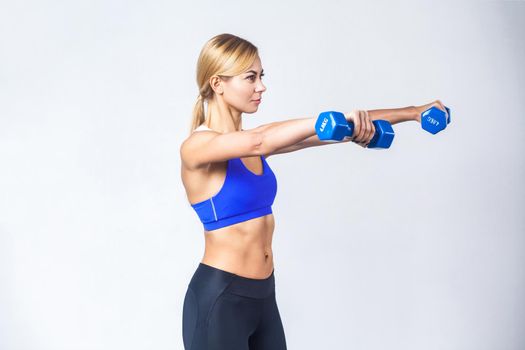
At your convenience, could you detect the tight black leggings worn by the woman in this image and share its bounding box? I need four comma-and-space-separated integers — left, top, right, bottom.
182, 263, 286, 350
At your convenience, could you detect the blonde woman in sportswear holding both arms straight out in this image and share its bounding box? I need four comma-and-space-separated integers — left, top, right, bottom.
180, 34, 444, 350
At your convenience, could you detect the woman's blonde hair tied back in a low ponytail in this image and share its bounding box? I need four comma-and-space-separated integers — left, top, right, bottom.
190, 33, 259, 133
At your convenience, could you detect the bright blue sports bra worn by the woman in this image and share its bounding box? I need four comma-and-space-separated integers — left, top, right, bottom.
191, 125, 277, 231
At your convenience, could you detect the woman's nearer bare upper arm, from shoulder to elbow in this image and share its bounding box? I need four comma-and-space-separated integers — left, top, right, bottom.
180, 129, 264, 168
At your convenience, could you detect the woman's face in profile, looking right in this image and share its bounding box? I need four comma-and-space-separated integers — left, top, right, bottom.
212, 56, 266, 113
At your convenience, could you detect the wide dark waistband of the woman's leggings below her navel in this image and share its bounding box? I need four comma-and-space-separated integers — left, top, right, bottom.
190, 263, 275, 299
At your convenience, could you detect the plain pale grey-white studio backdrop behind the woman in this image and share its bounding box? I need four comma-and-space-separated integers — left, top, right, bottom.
0, 1, 525, 350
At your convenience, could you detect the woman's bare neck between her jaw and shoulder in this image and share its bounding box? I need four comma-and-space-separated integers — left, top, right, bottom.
204, 97, 242, 134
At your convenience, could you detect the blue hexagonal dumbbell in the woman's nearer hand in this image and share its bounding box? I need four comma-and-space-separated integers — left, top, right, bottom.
315, 111, 394, 148
